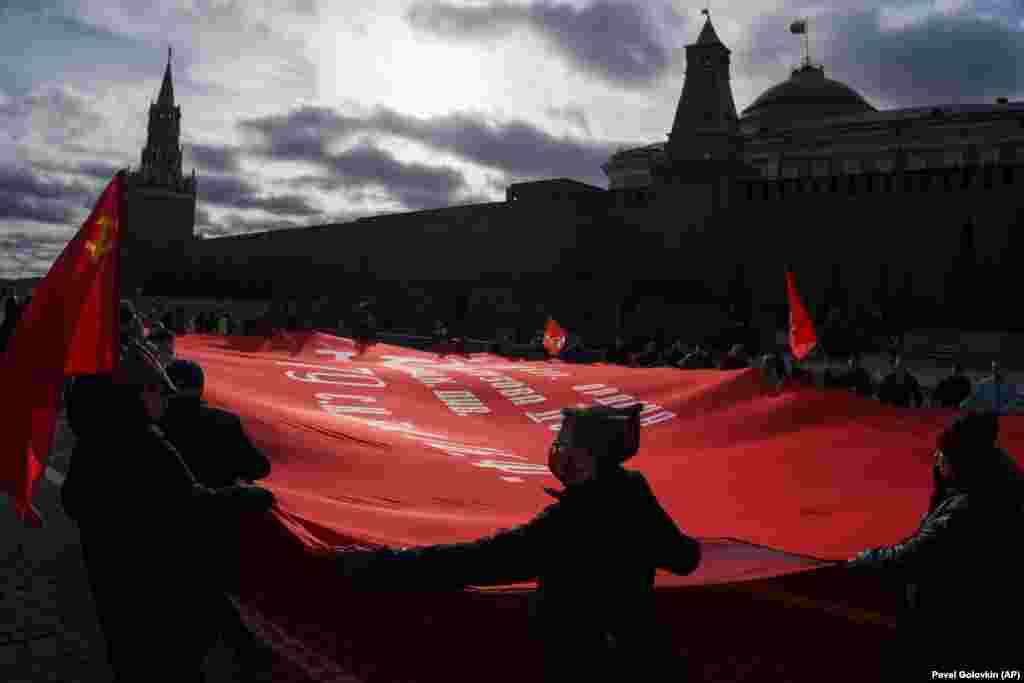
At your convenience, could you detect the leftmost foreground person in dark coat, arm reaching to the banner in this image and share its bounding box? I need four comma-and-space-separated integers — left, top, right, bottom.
60, 342, 273, 683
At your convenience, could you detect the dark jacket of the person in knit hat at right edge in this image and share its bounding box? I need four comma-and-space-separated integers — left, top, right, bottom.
849, 450, 1024, 671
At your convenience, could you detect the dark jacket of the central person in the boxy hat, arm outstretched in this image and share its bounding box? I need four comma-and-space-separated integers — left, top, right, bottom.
339, 466, 700, 680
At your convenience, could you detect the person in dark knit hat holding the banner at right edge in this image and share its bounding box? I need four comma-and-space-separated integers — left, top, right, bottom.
847, 413, 1024, 680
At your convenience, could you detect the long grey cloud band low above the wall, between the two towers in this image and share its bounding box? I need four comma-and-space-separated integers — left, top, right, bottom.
240, 108, 621, 190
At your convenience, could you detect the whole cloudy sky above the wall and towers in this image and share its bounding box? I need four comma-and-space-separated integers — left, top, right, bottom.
0, 0, 1024, 278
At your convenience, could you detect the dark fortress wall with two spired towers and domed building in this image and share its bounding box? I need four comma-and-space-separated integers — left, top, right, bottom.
123, 17, 1024, 342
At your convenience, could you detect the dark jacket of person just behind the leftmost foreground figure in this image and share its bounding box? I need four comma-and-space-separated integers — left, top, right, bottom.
162, 396, 270, 488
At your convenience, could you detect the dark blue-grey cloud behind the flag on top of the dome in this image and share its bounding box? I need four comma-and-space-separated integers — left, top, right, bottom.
742, 2, 1024, 109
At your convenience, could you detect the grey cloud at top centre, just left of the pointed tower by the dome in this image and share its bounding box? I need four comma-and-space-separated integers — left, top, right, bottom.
406, 0, 681, 87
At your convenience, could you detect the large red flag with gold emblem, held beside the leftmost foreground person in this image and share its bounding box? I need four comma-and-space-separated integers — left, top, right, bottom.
0, 171, 124, 526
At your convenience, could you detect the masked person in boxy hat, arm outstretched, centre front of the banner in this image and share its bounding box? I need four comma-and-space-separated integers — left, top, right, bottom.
336, 404, 700, 681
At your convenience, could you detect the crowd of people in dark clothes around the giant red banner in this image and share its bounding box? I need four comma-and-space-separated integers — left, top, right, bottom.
0, 297, 1024, 681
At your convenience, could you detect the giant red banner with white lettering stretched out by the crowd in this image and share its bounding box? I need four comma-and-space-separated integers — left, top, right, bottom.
178, 334, 1024, 681
